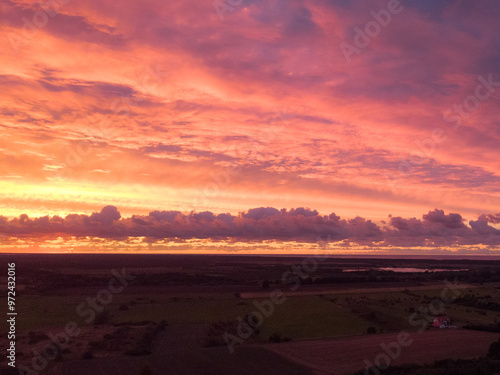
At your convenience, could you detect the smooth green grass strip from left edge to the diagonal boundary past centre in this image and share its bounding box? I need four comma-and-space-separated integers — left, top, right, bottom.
0, 294, 371, 340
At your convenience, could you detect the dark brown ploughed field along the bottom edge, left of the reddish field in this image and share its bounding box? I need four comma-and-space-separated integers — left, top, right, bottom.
61, 325, 313, 375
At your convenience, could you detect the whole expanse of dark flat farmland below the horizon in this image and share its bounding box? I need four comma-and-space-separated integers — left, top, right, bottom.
0, 255, 500, 375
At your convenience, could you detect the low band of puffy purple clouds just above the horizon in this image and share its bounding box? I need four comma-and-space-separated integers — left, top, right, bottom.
0, 206, 500, 247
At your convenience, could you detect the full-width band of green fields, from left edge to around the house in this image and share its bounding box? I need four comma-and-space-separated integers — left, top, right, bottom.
5, 287, 500, 340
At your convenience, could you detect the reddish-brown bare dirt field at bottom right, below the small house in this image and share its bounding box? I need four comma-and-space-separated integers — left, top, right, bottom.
266, 329, 499, 375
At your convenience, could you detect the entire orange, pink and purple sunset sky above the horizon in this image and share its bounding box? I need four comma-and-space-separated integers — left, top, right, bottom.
0, 0, 500, 255
